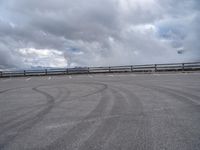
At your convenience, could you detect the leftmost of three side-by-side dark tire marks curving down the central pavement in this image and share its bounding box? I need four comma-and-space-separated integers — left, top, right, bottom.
41, 84, 109, 150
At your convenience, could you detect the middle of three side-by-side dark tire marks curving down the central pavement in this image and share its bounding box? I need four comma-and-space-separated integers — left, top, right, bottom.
78, 87, 126, 149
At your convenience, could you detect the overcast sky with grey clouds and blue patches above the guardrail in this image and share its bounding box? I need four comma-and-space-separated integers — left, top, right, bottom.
0, 0, 200, 70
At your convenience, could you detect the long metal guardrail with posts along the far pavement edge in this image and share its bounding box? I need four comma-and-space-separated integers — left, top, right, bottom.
0, 62, 200, 77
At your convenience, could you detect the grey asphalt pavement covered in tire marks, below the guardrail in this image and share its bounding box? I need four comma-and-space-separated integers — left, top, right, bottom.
0, 73, 200, 150
